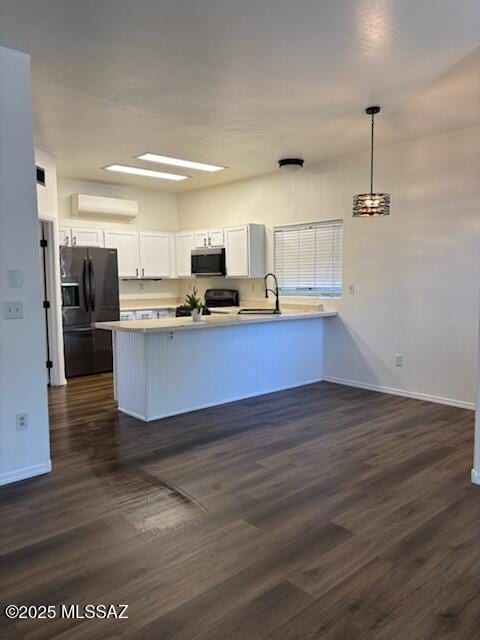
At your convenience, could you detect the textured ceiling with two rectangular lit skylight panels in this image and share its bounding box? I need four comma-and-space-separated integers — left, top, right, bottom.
0, 0, 480, 191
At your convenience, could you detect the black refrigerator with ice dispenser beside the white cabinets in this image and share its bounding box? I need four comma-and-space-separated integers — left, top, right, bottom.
60, 247, 120, 378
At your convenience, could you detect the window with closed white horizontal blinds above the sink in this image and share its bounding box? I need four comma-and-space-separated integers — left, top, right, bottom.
274, 220, 343, 298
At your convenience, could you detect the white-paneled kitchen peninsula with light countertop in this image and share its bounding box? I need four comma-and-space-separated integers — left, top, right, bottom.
96, 311, 336, 422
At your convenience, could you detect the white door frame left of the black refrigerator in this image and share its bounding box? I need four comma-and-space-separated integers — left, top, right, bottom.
38, 214, 67, 387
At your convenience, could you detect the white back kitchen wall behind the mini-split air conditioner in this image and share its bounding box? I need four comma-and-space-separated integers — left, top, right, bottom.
58, 177, 179, 301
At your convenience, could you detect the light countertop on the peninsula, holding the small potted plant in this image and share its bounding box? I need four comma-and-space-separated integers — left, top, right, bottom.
95, 307, 337, 333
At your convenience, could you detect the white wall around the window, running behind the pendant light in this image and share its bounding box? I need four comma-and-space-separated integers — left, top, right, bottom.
178, 126, 480, 407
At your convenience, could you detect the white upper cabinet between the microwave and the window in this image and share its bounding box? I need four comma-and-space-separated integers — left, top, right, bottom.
224, 224, 265, 278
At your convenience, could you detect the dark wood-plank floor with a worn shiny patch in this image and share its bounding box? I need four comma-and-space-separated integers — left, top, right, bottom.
0, 375, 480, 640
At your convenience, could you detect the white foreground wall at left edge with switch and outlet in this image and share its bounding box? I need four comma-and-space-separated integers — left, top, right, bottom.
0, 48, 51, 484
